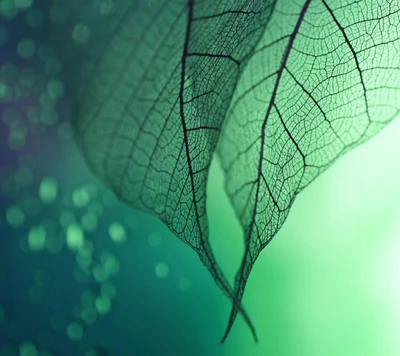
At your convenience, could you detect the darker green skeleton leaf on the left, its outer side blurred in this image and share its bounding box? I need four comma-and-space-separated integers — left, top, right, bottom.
52, 0, 274, 337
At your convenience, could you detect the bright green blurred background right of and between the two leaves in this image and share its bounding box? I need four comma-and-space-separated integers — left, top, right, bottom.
209, 122, 400, 356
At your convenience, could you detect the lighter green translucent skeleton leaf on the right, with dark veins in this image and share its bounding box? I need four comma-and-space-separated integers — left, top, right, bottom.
218, 0, 400, 340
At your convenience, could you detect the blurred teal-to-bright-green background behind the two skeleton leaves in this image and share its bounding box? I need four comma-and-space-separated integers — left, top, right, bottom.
0, 0, 400, 356
